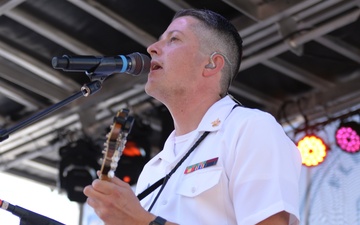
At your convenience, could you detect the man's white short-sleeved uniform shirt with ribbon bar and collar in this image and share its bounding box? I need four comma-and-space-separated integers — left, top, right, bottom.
136, 96, 301, 225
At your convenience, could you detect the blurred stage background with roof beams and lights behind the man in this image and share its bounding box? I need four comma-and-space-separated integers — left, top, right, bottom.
0, 0, 360, 225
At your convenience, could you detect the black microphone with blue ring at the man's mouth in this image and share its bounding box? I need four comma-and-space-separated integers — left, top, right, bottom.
52, 52, 151, 76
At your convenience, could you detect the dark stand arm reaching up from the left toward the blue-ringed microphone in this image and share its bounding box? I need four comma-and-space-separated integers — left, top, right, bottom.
0, 80, 102, 142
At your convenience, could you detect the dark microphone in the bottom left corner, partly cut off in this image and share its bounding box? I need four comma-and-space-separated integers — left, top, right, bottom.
0, 199, 65, 225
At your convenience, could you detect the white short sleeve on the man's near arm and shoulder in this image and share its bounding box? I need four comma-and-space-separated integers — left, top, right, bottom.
226, 111, 301, 225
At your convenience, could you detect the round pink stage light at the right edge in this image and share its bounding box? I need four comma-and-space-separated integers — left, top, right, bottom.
335, 122, 360, 153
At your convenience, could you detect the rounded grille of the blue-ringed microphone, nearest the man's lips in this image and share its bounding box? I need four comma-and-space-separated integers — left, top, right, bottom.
128, 52, 151, 76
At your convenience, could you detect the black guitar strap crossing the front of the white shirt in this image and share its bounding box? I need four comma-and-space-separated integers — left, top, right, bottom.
137, 104, 240, 212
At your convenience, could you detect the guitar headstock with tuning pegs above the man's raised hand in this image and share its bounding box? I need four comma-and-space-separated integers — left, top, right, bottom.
100, 109, 134, 180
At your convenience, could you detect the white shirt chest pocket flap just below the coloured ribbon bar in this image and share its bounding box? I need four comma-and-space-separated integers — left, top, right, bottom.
177, 168, 222, 197
